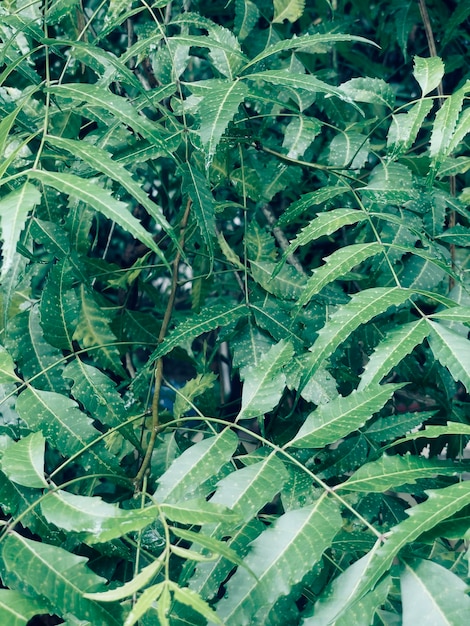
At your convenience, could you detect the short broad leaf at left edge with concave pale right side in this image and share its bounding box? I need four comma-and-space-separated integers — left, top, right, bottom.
0, 432, 48, 489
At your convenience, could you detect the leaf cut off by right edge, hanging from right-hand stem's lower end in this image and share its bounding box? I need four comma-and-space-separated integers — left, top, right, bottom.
428, 320, 470, 390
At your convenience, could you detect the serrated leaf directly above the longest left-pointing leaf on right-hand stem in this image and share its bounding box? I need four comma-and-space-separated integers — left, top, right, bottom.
298, 242, 383, 306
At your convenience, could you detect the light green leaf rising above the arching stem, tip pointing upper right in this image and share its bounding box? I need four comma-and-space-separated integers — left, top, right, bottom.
289, 384, 403, 448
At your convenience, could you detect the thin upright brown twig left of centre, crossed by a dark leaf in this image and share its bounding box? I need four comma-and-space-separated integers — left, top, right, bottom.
134, 200, 191, 489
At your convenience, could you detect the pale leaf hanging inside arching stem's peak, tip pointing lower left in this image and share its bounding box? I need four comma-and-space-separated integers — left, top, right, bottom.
153, 428, 238, 503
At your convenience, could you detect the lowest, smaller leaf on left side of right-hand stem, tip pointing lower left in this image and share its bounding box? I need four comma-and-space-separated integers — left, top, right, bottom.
358, 319, 429, 389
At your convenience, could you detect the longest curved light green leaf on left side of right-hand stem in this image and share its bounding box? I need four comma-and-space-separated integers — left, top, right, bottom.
303, 287, 412, 382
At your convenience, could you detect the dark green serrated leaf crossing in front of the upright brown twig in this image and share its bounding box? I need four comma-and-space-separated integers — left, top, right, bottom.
149, 302, 247, 363
